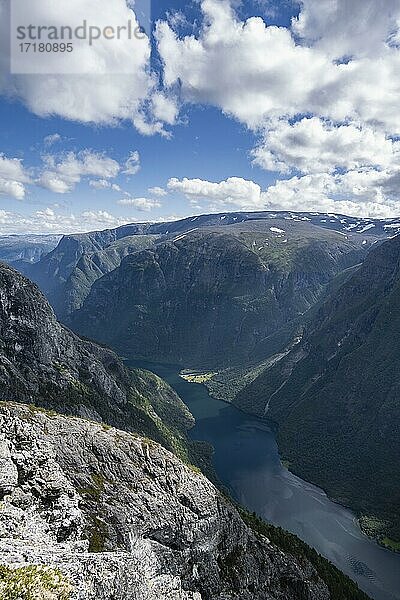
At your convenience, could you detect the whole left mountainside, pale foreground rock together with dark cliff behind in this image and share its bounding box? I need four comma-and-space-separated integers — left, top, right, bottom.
0, 265, 366, 600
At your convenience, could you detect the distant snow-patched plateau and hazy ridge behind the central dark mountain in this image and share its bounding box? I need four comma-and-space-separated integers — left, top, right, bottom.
18, 212, 390, 322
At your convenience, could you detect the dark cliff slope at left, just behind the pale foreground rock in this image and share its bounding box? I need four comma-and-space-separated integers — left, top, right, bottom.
0, 264, 193, 458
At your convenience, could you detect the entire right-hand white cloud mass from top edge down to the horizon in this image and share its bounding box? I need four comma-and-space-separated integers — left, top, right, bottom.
156, 0, 400, 216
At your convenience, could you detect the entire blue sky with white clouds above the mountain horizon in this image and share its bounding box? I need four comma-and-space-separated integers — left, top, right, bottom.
0, 0, 400, 233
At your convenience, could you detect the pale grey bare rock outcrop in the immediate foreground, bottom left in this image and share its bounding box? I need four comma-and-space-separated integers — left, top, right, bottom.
0, 403, 330, 600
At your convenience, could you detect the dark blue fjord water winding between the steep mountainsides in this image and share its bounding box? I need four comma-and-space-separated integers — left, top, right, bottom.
130, 361, 400, 600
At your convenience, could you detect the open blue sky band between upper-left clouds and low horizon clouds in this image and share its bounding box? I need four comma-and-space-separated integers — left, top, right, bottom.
0, 94, 274, 219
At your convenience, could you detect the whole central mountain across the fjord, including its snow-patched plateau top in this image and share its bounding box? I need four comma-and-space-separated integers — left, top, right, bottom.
18, 213, 390, 368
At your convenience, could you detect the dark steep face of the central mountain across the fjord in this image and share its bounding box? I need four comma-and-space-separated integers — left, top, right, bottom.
71, 221, 372, 367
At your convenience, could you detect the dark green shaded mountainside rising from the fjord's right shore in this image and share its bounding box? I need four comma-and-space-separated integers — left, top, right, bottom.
234, 236, 400, 547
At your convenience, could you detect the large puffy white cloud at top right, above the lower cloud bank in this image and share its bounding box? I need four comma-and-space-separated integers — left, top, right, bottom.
157, 0, 400, 134
